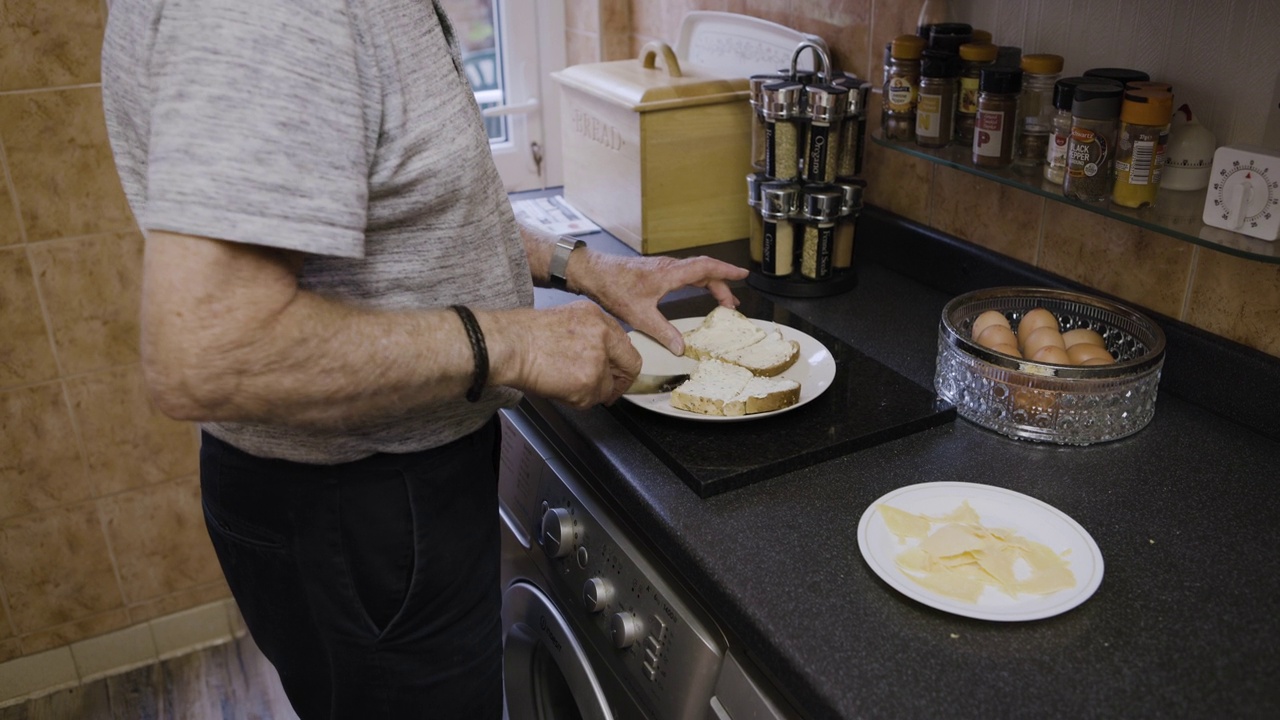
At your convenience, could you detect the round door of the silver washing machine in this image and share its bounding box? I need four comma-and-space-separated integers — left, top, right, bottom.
502, 582, 613, 720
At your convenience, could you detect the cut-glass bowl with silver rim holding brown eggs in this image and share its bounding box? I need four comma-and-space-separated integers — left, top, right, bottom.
933, 287, 1165, 445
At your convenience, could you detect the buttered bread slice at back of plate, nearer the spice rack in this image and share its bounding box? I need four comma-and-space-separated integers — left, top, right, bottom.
685, 307, 800, 377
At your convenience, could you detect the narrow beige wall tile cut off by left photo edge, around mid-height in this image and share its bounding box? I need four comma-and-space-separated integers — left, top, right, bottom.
0, 246, 58, 387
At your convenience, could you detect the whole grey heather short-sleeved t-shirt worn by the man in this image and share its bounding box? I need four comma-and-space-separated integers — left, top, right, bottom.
102, 0, 534, 462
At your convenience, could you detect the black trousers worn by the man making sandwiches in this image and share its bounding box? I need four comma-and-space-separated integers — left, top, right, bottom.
200, 419, 502, 720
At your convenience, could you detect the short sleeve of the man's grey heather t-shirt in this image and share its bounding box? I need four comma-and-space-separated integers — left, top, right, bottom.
140, 0, 376, 258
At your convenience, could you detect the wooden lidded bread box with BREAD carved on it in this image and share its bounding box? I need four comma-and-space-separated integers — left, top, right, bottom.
553, 42, 751, 255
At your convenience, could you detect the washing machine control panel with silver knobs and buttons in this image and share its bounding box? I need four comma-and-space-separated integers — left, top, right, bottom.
499, 409, 724, 719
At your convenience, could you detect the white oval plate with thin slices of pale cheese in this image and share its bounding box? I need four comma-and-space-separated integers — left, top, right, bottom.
858, 482, 1102, 621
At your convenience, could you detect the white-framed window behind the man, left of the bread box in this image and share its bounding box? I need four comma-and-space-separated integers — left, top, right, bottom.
442, 0, 564, 191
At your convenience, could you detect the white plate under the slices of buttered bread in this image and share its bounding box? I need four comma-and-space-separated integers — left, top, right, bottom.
622, 318, 836, 423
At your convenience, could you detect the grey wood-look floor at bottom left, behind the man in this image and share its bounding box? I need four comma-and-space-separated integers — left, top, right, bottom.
0, 634, 297, 720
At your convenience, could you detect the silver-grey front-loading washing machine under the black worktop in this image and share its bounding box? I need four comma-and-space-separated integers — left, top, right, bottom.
499, 406, 791, 720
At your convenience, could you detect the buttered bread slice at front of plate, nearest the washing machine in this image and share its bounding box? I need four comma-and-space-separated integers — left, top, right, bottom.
671, 360, 800, 416
